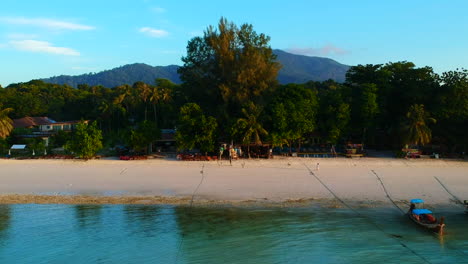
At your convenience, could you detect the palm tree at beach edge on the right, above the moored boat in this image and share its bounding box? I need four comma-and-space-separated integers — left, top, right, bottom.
404, 104, 436, 145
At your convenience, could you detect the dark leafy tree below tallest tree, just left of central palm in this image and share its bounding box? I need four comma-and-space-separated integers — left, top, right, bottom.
175, 103, 218, 152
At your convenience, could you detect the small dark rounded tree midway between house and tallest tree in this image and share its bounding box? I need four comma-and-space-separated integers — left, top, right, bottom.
129, 120, 161, 152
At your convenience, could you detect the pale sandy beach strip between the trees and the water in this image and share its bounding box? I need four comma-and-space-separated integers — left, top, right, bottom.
0, 158, 468, 206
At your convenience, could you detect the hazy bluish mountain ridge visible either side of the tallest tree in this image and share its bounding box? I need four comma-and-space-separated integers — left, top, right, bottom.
42, 50, 349, 87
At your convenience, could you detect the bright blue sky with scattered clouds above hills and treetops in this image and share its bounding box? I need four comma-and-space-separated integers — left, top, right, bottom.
0, 0, 468, 87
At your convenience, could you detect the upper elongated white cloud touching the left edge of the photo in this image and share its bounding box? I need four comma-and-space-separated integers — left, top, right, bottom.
0, 17, 95, 30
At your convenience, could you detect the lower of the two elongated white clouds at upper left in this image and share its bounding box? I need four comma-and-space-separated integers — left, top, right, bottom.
9, 40, 80, 56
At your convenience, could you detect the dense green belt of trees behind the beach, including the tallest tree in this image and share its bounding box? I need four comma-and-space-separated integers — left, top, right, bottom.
0, 19, 468, 157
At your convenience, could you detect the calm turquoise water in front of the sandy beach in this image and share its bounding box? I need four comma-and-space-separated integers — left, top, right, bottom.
0, 204, 468, 263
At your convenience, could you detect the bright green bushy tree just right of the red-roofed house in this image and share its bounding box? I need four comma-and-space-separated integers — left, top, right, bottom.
65, 121, 102, 159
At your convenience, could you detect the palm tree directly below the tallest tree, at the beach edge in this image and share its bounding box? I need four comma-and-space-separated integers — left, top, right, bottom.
234, 102, 268, 158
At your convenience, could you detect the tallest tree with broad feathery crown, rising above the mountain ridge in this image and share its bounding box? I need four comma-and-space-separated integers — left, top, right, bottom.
179, 18, 280, 130
